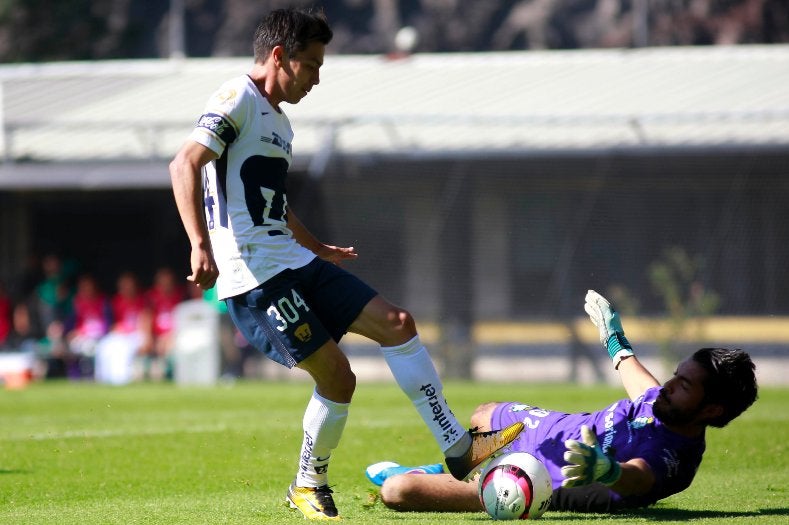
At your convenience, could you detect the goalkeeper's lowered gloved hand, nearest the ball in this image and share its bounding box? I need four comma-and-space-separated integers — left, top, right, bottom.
562, 425, 622, 487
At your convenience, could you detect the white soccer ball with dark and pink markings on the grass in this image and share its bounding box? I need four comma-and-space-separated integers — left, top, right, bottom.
478, 452, 553, 520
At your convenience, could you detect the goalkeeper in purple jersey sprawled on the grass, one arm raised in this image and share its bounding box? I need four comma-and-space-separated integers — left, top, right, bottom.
367, 290, 757, 512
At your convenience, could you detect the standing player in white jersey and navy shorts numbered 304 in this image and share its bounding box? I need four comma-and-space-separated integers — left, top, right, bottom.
170, 9, 523, 520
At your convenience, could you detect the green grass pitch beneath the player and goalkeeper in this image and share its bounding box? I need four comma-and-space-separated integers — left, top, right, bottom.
0, 382, 789, 525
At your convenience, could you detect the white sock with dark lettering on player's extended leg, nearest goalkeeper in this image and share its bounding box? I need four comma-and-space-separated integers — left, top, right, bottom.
381, 335, 470, 456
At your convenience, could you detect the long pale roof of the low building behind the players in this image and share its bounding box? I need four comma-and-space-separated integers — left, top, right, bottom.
0, 45, 789, 188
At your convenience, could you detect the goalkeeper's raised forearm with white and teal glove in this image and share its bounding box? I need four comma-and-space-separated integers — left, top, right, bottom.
584, 290, 660, 400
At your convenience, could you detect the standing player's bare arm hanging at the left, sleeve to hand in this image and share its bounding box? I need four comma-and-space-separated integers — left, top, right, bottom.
170, 140, 219, 289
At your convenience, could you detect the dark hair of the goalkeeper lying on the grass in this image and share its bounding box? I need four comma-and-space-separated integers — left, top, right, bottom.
691, 348, 758, 428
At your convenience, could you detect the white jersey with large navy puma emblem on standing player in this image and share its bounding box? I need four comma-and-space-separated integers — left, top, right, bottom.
189, 75, 315, 299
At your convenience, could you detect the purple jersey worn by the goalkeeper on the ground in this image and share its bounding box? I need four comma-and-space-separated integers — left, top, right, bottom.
490, 386, 705, 506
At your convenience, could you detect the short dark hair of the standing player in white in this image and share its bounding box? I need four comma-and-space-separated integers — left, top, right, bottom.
253, 8, 333, 63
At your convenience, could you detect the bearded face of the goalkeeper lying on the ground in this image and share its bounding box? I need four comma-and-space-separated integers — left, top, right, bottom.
652, 359, 706, 425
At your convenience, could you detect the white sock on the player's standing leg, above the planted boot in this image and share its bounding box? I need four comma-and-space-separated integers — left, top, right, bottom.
296, 386, 349, 487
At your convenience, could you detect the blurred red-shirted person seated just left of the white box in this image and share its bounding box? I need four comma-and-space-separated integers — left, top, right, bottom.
141, 268, 186, 380
